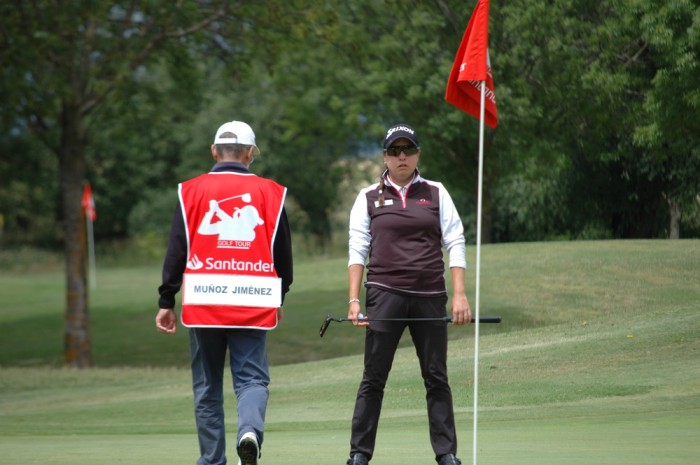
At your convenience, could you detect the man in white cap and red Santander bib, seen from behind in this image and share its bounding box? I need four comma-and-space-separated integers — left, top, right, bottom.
156, 121, 293, 465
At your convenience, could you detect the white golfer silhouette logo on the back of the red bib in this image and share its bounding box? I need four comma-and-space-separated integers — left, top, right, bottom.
197, 194, 265, 249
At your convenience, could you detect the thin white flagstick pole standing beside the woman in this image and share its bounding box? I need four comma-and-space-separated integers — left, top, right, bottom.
472, 80, 486, 465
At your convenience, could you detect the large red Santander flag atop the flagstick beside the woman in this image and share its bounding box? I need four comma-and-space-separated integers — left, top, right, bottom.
445, 0, 498, 128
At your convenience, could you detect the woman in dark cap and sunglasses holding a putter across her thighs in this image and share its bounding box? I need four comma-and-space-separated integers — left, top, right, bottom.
347, 124, 471, 465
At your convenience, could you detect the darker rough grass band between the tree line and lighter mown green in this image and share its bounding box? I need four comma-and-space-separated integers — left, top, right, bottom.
0, 240, 700, 367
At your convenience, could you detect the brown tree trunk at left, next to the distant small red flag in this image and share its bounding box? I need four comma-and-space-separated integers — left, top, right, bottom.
58, 103, 93, 368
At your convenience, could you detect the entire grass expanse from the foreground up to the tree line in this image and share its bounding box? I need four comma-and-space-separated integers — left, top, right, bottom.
0, 241, 700, 465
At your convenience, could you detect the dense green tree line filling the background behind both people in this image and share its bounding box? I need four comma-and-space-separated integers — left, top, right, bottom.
0, 0, 700, 366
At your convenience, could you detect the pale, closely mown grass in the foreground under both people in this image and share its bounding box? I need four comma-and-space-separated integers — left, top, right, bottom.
0, 307, 700, 465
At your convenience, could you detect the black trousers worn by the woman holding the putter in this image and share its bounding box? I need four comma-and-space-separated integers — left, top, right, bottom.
350, 288, 457, 458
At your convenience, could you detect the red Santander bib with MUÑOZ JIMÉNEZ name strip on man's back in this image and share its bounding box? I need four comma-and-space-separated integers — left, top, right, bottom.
179, 171, 287, 330
